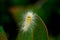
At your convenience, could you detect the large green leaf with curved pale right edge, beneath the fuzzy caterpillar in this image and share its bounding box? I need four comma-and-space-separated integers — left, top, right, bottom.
17, 9, 48, 40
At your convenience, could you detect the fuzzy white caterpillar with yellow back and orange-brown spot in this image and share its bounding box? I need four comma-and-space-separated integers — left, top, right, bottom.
22, 11, 34, 32
